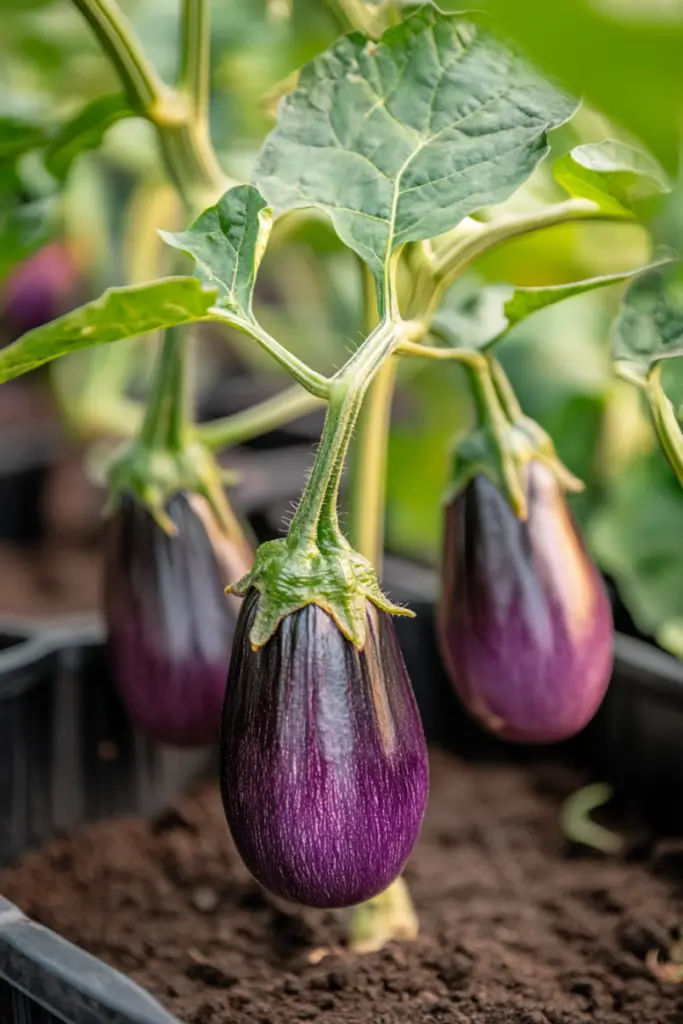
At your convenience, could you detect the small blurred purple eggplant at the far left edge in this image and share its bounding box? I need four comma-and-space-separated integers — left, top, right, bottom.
2, 242, 79, 337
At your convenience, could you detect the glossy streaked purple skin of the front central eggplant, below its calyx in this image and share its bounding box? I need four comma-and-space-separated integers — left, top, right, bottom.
221, 590, 429, 907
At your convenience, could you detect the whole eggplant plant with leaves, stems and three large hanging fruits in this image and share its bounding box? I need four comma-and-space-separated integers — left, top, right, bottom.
0, 0, 683, 948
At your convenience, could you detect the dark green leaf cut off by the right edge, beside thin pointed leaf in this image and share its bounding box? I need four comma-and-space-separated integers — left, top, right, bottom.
612, 260, 683, 384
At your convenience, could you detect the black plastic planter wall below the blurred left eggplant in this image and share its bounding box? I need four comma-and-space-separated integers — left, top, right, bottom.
0, 620, 211, 863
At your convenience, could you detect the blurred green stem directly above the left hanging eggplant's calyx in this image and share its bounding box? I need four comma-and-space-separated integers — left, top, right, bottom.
139, 328, 188, 452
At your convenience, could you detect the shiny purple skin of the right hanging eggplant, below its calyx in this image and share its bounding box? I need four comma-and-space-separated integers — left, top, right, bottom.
438, 462, 612, 743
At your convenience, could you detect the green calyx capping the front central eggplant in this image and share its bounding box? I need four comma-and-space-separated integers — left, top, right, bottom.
228, 538, 413, 650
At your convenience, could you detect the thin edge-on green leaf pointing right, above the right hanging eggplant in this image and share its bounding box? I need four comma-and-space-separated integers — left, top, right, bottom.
434, 249, 676, 349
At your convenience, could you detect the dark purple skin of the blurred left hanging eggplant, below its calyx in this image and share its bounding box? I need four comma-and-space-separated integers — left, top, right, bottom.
104, 494, 250, 746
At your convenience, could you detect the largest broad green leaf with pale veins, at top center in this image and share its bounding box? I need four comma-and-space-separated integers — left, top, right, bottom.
255, 6, 575, 301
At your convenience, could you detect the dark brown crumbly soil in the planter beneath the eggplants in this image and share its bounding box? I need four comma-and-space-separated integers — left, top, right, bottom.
0, 753, 683, 1024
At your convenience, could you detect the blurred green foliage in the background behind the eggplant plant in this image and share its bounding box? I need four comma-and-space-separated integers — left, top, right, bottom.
0, 0, 683, 655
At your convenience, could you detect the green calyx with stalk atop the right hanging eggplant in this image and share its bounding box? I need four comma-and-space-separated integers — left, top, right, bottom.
445, 359, 584, 520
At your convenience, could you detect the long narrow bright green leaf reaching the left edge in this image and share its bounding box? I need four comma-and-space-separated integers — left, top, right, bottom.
0, 278, 216, 384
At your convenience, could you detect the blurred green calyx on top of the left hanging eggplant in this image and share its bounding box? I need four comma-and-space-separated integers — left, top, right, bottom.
106, 437, 233, 534
